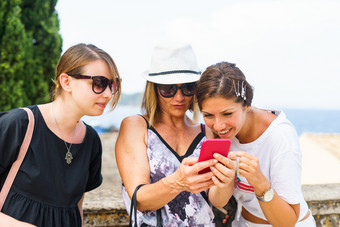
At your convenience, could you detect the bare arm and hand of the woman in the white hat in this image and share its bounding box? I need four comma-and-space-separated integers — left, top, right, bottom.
115, 116, 215, 211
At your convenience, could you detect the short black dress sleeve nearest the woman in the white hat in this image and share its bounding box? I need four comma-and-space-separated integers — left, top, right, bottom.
85, 127, 103, 192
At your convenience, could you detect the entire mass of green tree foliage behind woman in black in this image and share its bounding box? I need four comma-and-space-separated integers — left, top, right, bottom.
0, 0, 62, 111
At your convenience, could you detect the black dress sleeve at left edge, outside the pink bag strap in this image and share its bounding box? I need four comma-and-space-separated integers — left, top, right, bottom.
0, 109, 28, 175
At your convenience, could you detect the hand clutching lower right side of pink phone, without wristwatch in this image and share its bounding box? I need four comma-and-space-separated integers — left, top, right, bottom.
210, 153, 236, 188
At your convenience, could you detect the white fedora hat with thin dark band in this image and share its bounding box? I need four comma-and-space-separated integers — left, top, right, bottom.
145, 43, 201, 84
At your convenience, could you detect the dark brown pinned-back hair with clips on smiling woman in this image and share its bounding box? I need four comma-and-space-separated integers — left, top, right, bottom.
196, 62, 253, 109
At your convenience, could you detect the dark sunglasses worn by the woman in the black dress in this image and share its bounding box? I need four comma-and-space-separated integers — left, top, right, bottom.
68, 74, 121, 94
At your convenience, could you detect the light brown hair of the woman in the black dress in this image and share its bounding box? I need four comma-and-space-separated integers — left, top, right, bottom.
51, 43, 121, 109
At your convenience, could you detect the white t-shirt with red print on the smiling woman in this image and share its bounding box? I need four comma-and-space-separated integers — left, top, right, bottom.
230, 111, 308, 220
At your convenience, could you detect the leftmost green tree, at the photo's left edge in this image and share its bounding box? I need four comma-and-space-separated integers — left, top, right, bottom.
0, 0, 29, 110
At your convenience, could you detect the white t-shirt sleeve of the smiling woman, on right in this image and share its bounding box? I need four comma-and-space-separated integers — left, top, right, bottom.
270, 125, 302, 204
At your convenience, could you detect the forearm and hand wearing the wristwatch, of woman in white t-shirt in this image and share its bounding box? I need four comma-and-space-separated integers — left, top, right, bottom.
230, 151, 300, 226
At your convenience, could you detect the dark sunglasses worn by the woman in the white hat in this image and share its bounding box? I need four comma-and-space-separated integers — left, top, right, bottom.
156, 82, 196, 98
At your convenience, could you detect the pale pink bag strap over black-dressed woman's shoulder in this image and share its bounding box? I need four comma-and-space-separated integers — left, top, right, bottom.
0, 107, 34, 210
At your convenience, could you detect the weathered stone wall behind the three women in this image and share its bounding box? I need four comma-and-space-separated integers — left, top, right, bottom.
84, 184, 340, 227
